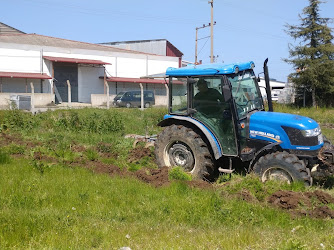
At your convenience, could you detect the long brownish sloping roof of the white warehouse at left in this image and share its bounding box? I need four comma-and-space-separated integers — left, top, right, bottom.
0, 34, 155, 55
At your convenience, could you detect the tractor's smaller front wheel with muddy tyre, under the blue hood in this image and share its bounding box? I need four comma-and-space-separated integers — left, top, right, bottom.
254, 152, 312, 186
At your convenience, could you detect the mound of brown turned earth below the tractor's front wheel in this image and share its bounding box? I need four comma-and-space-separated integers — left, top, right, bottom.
268, 190, 334, 219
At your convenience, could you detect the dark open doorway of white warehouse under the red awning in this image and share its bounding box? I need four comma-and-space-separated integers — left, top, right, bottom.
53, 63, 78, 103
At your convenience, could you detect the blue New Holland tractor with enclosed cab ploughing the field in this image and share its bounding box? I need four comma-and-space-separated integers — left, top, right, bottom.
155, 59, 334, 185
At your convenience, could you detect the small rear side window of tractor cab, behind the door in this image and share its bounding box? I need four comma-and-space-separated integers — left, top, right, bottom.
169, 78, 188, 115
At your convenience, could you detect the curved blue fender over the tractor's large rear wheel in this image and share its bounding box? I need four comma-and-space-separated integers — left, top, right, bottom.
158, 115, 223, 160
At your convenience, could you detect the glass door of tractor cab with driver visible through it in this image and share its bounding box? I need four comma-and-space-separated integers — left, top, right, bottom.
188, 76, 238, 156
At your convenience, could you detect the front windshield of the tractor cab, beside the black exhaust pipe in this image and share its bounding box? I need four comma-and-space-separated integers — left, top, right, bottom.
228, 70, 264, 119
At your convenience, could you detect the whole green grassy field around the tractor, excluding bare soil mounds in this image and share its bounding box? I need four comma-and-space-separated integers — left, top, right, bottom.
0, 106, 334, 249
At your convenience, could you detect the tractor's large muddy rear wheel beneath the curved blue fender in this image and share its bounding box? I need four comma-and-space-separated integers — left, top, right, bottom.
155, 125, 215, 180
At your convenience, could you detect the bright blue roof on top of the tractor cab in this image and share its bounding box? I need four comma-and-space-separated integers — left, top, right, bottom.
166, 61, 255, 76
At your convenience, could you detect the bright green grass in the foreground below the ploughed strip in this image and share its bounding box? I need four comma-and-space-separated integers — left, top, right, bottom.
0, 159, 334, 249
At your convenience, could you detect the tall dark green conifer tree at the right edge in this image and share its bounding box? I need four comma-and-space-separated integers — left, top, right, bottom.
284, 0, 334, 107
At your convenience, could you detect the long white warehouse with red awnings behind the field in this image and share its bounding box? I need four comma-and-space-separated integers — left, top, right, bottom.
0, 26, 180, 107
